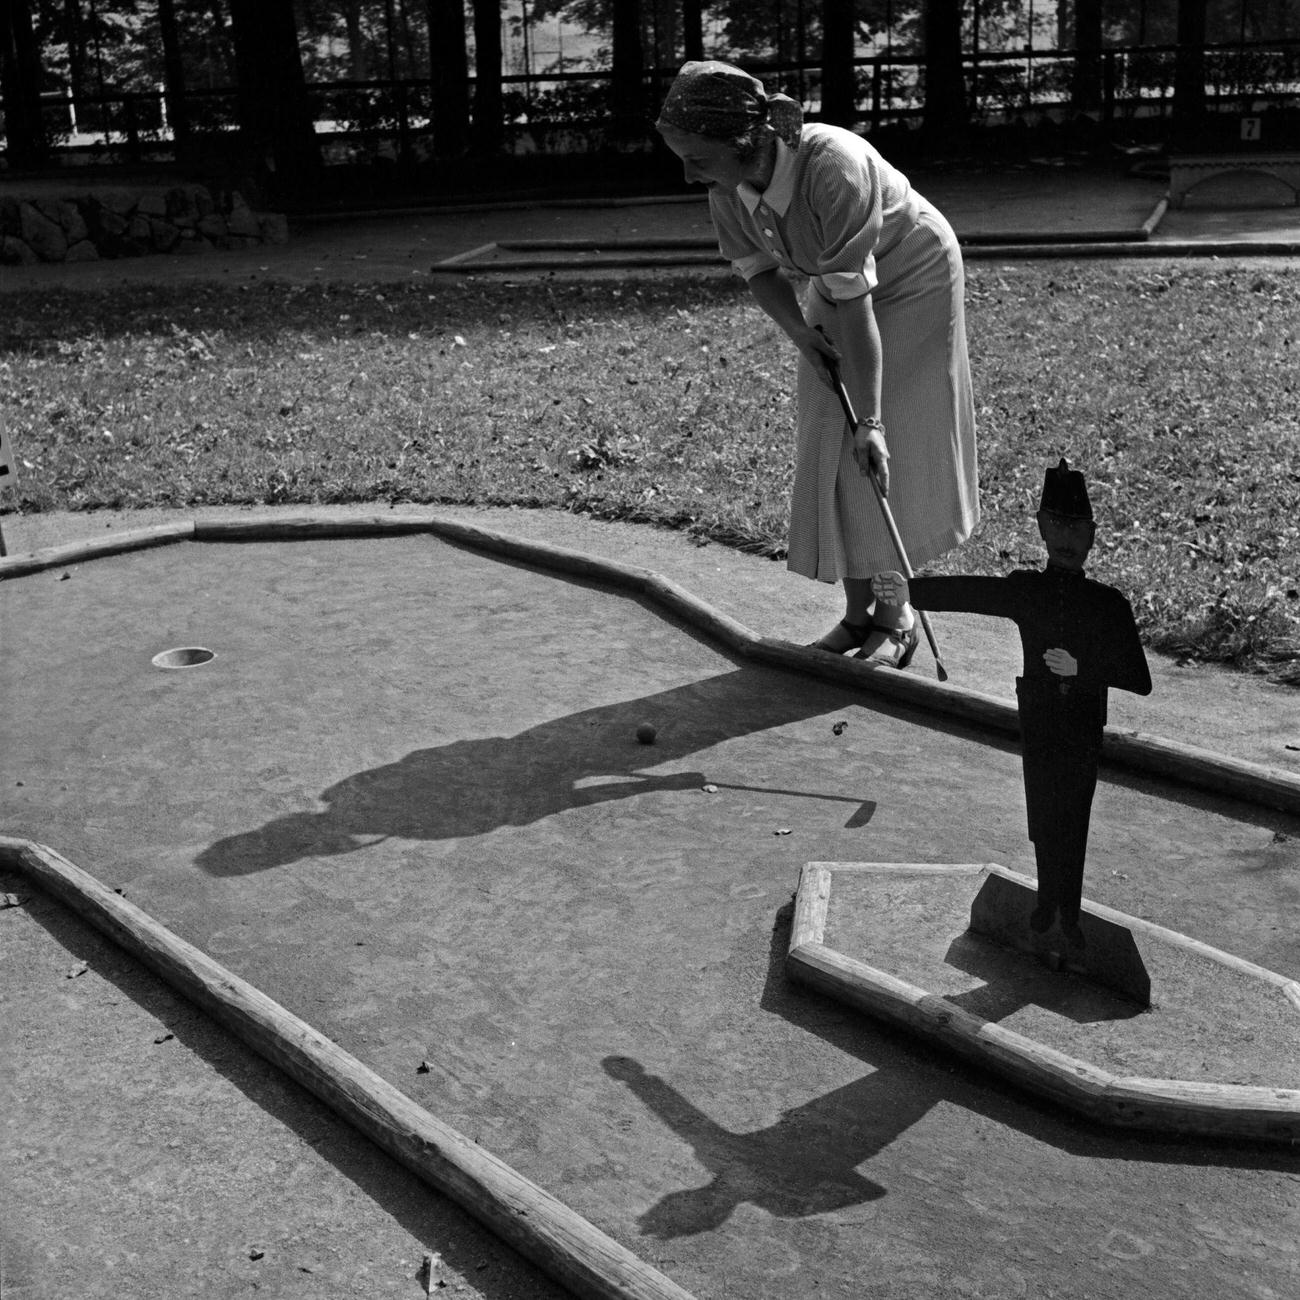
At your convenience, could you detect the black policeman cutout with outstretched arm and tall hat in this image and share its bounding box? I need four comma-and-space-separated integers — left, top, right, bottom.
874, 459, 1151, 950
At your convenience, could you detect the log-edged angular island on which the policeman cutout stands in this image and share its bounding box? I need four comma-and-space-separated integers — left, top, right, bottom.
787, 862, 1300, 1143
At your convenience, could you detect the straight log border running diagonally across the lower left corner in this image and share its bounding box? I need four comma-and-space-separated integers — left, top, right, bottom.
0, 836, 693, 1300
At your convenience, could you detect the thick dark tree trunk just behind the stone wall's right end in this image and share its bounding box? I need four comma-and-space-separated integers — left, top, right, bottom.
230, 0, 320, 195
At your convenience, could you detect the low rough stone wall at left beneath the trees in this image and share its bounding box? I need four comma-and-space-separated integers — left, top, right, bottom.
0, 185, 289, 267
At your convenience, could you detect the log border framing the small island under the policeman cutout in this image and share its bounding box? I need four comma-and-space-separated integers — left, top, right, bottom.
785, 862, 1300, 1144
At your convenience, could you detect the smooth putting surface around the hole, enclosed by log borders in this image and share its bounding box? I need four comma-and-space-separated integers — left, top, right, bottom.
0, 536, 1300, 1297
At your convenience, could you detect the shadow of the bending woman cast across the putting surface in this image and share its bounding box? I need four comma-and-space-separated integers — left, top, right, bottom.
196, 667, 883, 876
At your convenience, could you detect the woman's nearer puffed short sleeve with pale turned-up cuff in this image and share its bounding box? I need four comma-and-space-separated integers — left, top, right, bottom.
806, 140, 884, 302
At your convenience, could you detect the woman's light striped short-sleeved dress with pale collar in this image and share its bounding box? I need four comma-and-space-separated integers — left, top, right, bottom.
710, 124, 979, 582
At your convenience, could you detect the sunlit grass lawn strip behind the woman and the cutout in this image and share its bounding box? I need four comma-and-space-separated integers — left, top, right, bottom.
0, 269, 1300, 684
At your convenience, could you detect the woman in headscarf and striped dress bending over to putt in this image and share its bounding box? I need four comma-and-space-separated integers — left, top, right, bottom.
655, 62, 979, 668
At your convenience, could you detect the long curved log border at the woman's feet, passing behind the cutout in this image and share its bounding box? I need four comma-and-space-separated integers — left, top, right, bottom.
0, 514, 1300, 814
